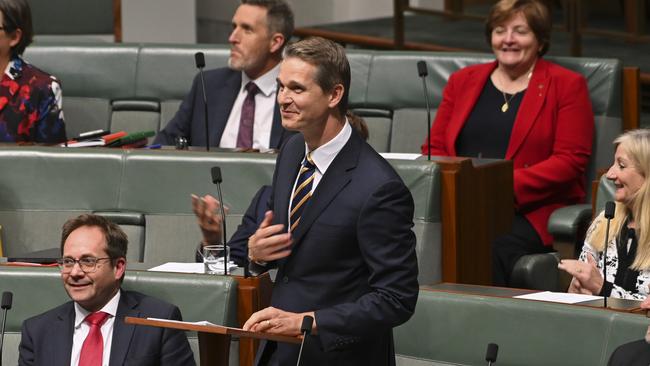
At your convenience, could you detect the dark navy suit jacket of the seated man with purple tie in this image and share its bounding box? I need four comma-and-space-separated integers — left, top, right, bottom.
154, 67, 290, 149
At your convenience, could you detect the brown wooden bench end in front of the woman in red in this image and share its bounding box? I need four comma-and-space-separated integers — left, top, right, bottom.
436, 158, 514, 285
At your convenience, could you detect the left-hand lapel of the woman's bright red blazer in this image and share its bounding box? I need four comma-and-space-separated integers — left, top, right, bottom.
447, 61, 497, 156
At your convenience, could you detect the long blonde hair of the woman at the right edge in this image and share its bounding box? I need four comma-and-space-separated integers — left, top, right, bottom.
587, 128, 650, 271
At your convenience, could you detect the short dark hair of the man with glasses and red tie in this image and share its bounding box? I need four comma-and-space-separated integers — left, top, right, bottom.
61, 214, 129, 263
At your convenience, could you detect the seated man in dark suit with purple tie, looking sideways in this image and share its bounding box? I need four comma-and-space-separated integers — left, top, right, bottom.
155, 0, 293, 149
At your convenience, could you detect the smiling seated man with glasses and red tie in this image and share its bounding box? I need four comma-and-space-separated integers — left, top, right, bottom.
18, 215, 195, 366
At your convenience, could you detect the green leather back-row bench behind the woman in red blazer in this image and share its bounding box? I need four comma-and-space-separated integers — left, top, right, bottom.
25, 43, 622, 159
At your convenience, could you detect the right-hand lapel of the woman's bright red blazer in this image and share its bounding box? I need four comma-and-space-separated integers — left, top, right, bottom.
505, 59, 550, 160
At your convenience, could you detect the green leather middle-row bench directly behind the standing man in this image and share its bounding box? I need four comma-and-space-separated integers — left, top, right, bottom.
0, 146, 441, 284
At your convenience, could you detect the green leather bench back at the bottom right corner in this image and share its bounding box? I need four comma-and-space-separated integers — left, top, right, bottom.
394, 289, 650, 366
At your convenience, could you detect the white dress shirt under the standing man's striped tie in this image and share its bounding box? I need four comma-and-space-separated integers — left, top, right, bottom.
287, 118, 352, 228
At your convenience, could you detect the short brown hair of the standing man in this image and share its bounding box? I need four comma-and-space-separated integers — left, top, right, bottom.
284, 37, 350, 116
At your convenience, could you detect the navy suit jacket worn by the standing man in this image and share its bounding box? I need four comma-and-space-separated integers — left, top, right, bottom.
258, 131, 418, 366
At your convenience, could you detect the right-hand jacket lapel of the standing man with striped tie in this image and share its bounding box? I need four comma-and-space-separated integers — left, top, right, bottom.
293, 131, 363, 248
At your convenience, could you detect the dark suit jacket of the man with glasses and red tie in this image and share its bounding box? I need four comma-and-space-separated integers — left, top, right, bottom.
18, 291, 195, 366
